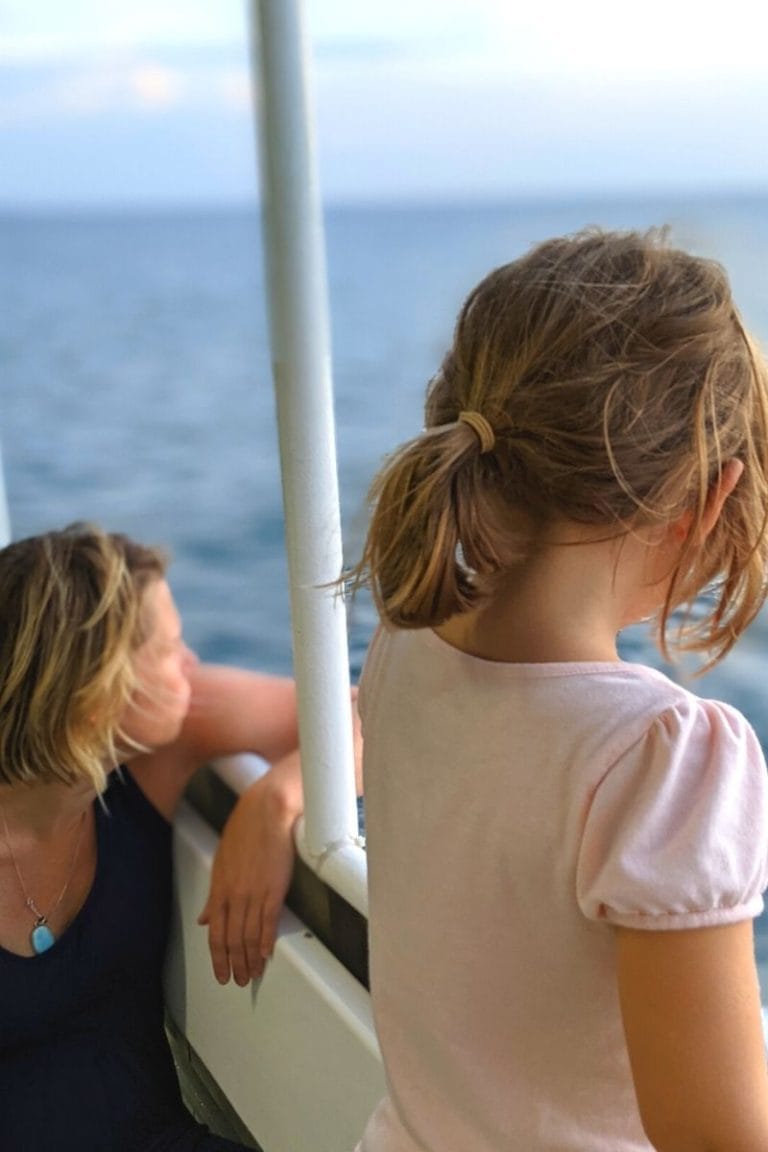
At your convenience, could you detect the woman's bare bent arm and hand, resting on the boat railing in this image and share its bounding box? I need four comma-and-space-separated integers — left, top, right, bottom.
130, 664, 362, 985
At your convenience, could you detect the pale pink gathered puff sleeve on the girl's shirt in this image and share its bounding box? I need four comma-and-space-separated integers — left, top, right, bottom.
577, 696, 768, 930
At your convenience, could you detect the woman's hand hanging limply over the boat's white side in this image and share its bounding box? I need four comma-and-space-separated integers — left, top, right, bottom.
198, 751, 302, 987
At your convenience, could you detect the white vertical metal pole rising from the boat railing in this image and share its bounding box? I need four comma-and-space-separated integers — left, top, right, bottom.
251, 0, 357, 861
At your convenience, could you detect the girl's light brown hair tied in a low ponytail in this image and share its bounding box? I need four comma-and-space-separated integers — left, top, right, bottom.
352, 229, 768, 664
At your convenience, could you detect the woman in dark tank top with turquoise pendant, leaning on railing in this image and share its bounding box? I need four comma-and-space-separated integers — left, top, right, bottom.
0, 525, 313, 1152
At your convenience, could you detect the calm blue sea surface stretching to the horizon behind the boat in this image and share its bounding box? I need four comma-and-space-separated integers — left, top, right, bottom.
0, 198, 768, 961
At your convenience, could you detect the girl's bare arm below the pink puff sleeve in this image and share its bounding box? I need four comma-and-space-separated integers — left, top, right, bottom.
616, 920, 768, 1152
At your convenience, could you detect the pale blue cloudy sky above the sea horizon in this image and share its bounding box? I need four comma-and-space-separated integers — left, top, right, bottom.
0, 0, 768, 210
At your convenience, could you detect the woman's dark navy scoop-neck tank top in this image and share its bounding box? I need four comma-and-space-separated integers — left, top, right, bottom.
0, 770, 251, 1152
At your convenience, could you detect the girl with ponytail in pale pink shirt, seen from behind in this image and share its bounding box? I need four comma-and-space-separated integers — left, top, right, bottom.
352, 230, 768, 1152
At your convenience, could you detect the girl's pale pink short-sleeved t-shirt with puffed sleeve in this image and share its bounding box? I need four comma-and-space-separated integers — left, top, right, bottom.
359, 630, 768, 1152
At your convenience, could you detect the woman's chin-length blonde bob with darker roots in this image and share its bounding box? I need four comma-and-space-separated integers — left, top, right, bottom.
0, 524, 167, 791
